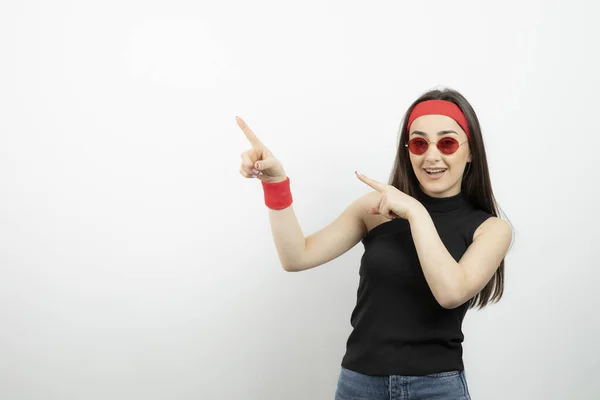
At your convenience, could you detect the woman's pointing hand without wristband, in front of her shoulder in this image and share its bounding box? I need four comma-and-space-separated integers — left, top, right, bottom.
354, 171, 423, 219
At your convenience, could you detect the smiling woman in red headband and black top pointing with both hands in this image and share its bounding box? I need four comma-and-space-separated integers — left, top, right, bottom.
237, 89, 512, 400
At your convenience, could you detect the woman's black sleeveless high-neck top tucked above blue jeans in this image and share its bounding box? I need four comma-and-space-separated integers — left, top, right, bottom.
342, 189, 493, 375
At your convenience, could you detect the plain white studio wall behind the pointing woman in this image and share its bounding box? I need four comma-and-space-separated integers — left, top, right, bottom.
0, 0, 600, 400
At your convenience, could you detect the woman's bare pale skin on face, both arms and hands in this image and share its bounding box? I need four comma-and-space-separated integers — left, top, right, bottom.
238, 115, 512, 309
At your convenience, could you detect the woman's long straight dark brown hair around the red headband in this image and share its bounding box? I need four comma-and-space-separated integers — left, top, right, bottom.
388, 89, 504, 309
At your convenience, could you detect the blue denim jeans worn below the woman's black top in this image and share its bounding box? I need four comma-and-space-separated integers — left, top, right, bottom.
335, 367, 471, 400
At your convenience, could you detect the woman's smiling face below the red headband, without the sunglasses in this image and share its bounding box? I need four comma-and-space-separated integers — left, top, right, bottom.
408, 115, 472, 197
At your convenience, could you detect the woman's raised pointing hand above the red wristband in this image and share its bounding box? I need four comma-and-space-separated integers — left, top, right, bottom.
235, 116, 287, 183
